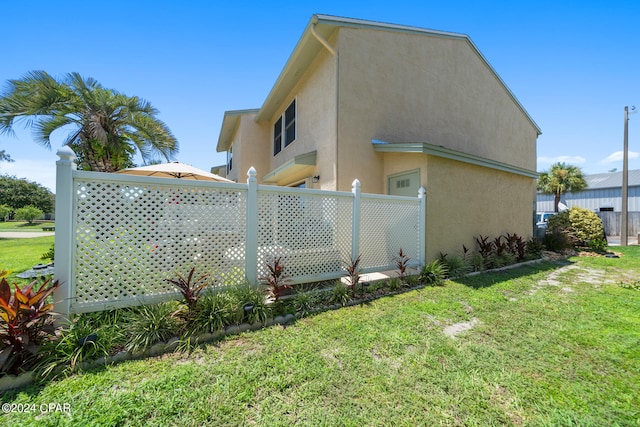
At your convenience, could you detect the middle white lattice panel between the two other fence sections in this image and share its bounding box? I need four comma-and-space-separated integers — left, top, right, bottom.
258, 189, 353, 282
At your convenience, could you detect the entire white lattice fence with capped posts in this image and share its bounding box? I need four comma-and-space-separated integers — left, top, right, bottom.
55, 147, 426, 314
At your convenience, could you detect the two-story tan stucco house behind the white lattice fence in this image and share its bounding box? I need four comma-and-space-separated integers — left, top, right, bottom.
217, 15, 540, 259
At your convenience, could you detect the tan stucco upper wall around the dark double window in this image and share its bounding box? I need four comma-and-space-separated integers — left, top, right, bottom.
267, 31, 337, 190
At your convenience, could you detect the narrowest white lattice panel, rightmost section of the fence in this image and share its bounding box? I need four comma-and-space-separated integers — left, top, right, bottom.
360, 195, 420, 269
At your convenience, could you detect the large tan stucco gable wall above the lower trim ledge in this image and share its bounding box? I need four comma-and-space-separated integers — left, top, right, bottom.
338, 28, 537, 192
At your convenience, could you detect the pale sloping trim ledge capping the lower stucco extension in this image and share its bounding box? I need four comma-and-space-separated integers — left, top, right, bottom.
371, 139, 538, 179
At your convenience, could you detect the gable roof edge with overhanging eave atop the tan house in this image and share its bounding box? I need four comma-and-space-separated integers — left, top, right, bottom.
255, 15, 542, 135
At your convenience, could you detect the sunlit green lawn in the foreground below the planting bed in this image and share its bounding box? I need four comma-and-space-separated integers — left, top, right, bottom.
0, 247, 640, 426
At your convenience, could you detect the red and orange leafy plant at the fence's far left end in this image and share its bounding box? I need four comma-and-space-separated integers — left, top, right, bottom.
0, 278, 60, 374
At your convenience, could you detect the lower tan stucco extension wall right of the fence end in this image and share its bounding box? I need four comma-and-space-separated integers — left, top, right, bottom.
426, 156, 535, 260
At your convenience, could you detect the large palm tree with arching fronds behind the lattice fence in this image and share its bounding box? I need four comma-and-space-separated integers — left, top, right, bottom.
0, 71, 178, 172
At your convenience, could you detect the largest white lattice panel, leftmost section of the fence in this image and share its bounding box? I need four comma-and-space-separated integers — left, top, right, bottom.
71, 178, 246, 312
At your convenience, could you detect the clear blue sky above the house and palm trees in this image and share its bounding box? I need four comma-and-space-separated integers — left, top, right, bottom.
0, 0, 640, 190
